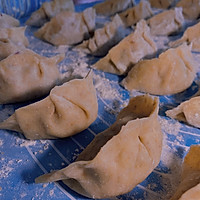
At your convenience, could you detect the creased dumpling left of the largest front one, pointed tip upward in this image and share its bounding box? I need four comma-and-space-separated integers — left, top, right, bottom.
0, 71, 98, 139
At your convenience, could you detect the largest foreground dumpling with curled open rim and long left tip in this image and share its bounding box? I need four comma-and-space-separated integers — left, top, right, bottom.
36, 95, 162, 199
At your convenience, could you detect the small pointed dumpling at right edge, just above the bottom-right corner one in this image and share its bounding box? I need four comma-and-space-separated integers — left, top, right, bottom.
166, 97, 200, 128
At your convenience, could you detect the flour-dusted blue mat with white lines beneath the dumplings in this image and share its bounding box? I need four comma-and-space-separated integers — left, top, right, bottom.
0, 1, 200, 200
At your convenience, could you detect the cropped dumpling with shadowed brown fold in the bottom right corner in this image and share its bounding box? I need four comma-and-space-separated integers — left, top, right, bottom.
170, 145, 200, 200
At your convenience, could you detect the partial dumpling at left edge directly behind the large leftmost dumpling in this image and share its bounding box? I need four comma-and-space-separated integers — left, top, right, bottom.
0, 38, 25, 60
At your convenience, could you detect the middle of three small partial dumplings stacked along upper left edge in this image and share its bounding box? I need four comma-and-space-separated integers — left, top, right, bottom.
0, 27, 29, 47
